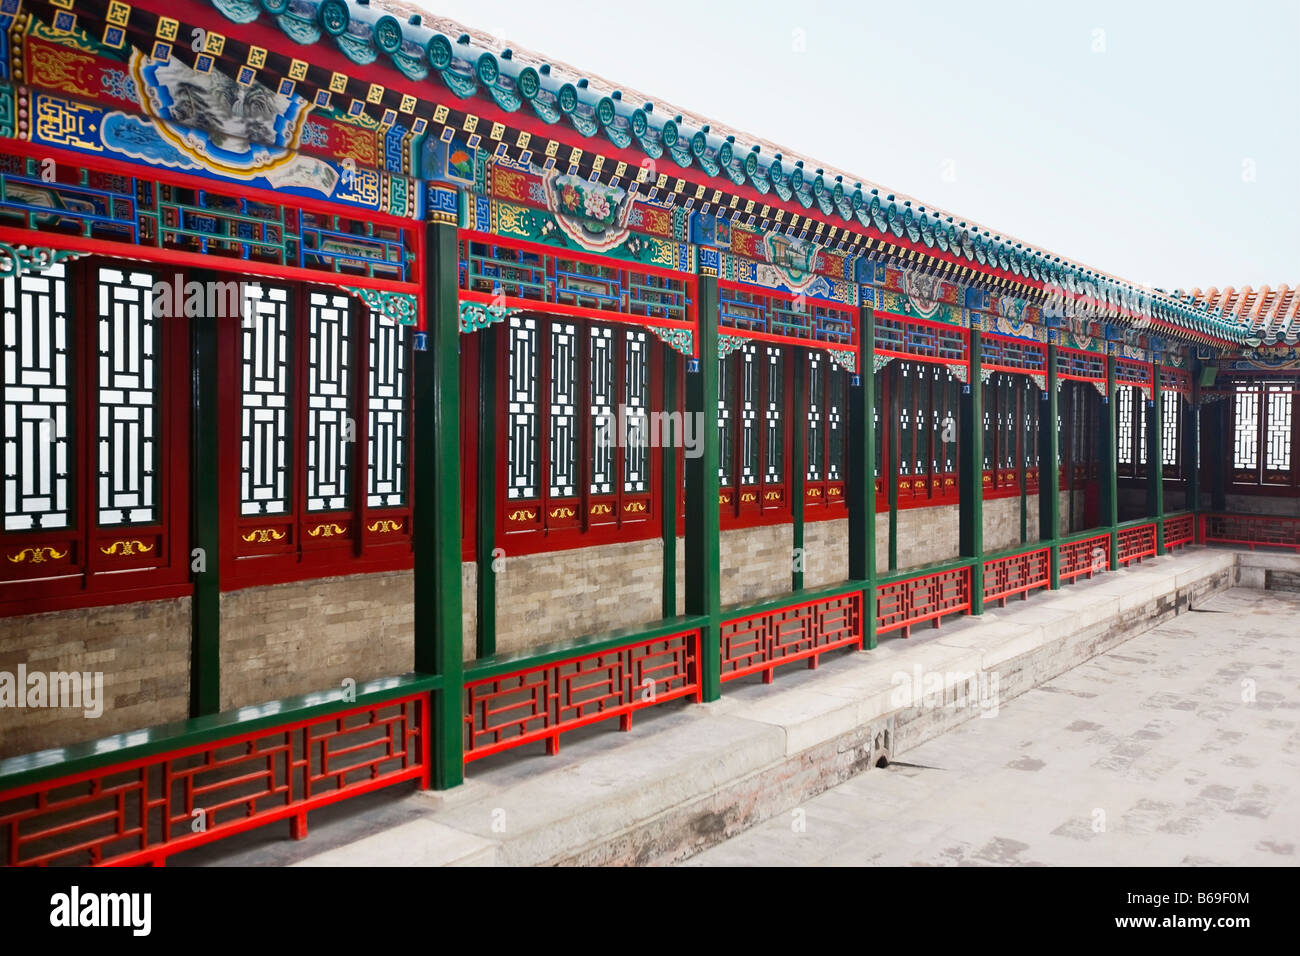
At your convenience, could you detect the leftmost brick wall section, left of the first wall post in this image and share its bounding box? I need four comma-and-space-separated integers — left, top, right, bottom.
0, 597, 190, 757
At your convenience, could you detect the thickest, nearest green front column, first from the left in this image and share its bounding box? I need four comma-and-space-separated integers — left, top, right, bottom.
411, 222, 464, 790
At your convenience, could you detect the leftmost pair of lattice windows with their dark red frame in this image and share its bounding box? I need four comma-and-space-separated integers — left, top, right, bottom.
0, 259, 190, 614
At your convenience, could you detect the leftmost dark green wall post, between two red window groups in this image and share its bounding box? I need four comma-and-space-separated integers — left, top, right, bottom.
189, 295, 220, 717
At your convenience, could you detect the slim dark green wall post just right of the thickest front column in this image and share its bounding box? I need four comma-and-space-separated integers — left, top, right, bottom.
478, 325, 503, 657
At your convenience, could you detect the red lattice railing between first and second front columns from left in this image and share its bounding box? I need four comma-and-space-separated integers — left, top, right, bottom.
464, 631, 699, 763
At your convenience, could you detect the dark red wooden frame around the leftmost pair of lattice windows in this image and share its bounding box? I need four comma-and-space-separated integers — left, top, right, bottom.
0, 256, 192, 617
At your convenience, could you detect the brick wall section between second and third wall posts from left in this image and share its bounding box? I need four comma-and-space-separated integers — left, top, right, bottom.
497, 538, 665, 654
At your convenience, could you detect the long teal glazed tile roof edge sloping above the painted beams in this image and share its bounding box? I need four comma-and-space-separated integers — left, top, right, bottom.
192, 0, 1245, 343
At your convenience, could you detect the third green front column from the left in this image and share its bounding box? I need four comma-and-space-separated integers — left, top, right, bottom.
848, 307, 876, 650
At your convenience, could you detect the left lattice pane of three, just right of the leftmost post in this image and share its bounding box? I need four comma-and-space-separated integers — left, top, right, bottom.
239, 285, 293, 515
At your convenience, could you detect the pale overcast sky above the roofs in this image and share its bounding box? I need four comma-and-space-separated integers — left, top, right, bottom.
420, 0, 1300, 289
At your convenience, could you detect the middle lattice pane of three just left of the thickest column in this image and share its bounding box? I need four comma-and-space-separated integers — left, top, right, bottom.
307, 290, 356, 511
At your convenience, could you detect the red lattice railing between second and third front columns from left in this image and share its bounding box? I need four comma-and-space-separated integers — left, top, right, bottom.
722, 591, 862, 683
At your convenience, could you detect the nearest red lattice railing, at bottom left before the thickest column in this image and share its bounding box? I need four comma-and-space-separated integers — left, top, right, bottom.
0, 692, 430, 866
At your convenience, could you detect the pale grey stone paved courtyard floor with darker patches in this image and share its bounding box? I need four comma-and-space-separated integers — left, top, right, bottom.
686, 589, 1300, 866
